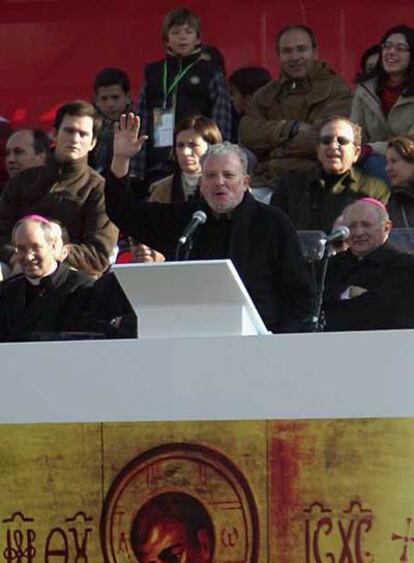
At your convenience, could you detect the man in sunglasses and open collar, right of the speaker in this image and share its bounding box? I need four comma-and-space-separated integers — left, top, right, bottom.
271, 116, 389, 231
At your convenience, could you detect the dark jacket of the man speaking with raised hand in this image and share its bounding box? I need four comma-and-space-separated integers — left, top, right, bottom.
106, 174, 313, 332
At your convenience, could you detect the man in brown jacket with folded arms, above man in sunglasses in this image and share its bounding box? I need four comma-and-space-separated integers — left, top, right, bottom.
239, 25, 352, 187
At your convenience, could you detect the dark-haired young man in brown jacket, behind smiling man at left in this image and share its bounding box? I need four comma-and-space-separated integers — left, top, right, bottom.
0, 101, 118, 275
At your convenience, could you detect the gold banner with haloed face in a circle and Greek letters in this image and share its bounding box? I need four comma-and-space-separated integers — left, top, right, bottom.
0, 418, 414, 563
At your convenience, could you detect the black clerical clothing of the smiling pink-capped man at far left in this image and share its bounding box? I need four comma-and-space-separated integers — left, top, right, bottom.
0, 263, 94, 342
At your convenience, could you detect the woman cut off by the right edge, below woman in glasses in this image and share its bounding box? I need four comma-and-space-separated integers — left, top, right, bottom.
386, 136, 414, 228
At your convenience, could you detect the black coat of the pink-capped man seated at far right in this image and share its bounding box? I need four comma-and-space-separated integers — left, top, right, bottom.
324, 242, 414, 331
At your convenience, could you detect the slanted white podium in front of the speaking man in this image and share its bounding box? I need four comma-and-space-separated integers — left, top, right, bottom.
113, 260, 268, 338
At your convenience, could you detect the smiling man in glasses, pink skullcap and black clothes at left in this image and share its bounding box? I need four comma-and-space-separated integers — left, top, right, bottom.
0, 215, 93, 342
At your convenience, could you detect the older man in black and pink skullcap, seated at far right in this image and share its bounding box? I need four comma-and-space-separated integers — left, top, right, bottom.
324, 198, 414, 331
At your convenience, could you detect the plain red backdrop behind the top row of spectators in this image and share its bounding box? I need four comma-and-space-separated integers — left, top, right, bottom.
0, 0, 414, 129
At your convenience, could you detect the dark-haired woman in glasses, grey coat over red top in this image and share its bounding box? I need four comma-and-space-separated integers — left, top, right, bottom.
351, 25, 414, 179
